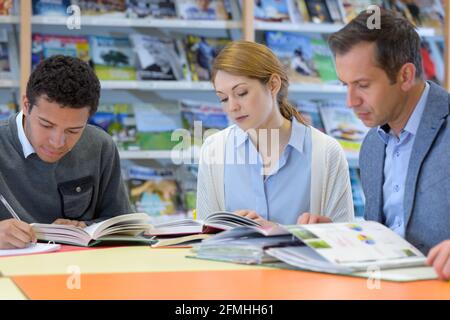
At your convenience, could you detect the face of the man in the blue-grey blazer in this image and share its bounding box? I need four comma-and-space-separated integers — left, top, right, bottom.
336, 42, 406, 127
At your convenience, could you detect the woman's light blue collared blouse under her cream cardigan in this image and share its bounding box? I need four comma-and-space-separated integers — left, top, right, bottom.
224, 119, 312, 224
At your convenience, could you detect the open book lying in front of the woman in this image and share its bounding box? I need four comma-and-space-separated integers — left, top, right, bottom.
146, 211, 262, 236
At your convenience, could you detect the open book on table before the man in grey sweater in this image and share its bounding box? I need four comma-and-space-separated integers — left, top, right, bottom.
31, 213, 150, 247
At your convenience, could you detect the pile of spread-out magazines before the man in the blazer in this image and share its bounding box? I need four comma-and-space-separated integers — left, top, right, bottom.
189, 221, 436, 281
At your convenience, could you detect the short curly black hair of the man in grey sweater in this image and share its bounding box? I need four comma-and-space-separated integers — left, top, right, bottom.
26, 55, 100, 115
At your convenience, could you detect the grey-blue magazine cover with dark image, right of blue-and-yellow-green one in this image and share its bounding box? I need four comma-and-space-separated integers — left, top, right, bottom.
130, 34, 187, 80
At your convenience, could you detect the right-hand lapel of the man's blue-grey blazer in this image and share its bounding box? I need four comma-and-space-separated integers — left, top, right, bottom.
404, 82, 449, 228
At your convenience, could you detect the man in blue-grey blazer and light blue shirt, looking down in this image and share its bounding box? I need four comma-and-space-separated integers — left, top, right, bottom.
329, 10, 450, 279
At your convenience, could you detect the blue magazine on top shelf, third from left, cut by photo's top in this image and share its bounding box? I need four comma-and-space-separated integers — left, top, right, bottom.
127, 0, 177, 19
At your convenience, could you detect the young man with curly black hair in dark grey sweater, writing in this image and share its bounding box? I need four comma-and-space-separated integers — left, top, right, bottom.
0, 56, 131, 249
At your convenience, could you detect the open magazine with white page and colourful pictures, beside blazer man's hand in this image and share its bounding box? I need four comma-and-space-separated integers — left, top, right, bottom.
266, 221, 436, 281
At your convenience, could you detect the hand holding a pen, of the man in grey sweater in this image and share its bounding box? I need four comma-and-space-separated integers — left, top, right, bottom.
0, 219, 37, 249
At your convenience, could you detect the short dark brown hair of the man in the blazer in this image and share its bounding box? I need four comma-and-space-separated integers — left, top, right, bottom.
328, 9, 423, 83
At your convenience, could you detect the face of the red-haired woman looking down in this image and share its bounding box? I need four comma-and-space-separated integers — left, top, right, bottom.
214, 70, 277, 131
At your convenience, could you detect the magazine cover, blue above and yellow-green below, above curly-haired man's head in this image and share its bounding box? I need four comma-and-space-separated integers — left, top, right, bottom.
90, 36, 136, 80
